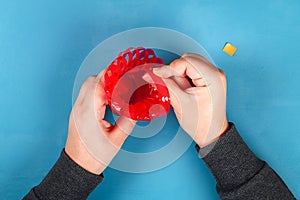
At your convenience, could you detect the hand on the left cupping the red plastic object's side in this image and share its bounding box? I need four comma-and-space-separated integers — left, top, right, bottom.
65, 72, 135, 174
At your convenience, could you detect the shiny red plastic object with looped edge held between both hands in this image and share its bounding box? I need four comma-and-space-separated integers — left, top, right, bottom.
104, 47, 170, 121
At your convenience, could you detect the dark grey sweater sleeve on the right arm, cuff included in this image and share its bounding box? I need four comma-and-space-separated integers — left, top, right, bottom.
196, 123, 295, 200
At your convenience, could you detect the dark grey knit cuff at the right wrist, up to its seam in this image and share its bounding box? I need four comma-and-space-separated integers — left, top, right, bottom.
196, 123, 265, 190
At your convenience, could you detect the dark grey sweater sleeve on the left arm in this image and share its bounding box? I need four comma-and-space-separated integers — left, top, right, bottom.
23, 150, 103, 200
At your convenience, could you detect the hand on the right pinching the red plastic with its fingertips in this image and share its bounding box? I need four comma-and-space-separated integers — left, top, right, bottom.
153, 53, 228, 147
